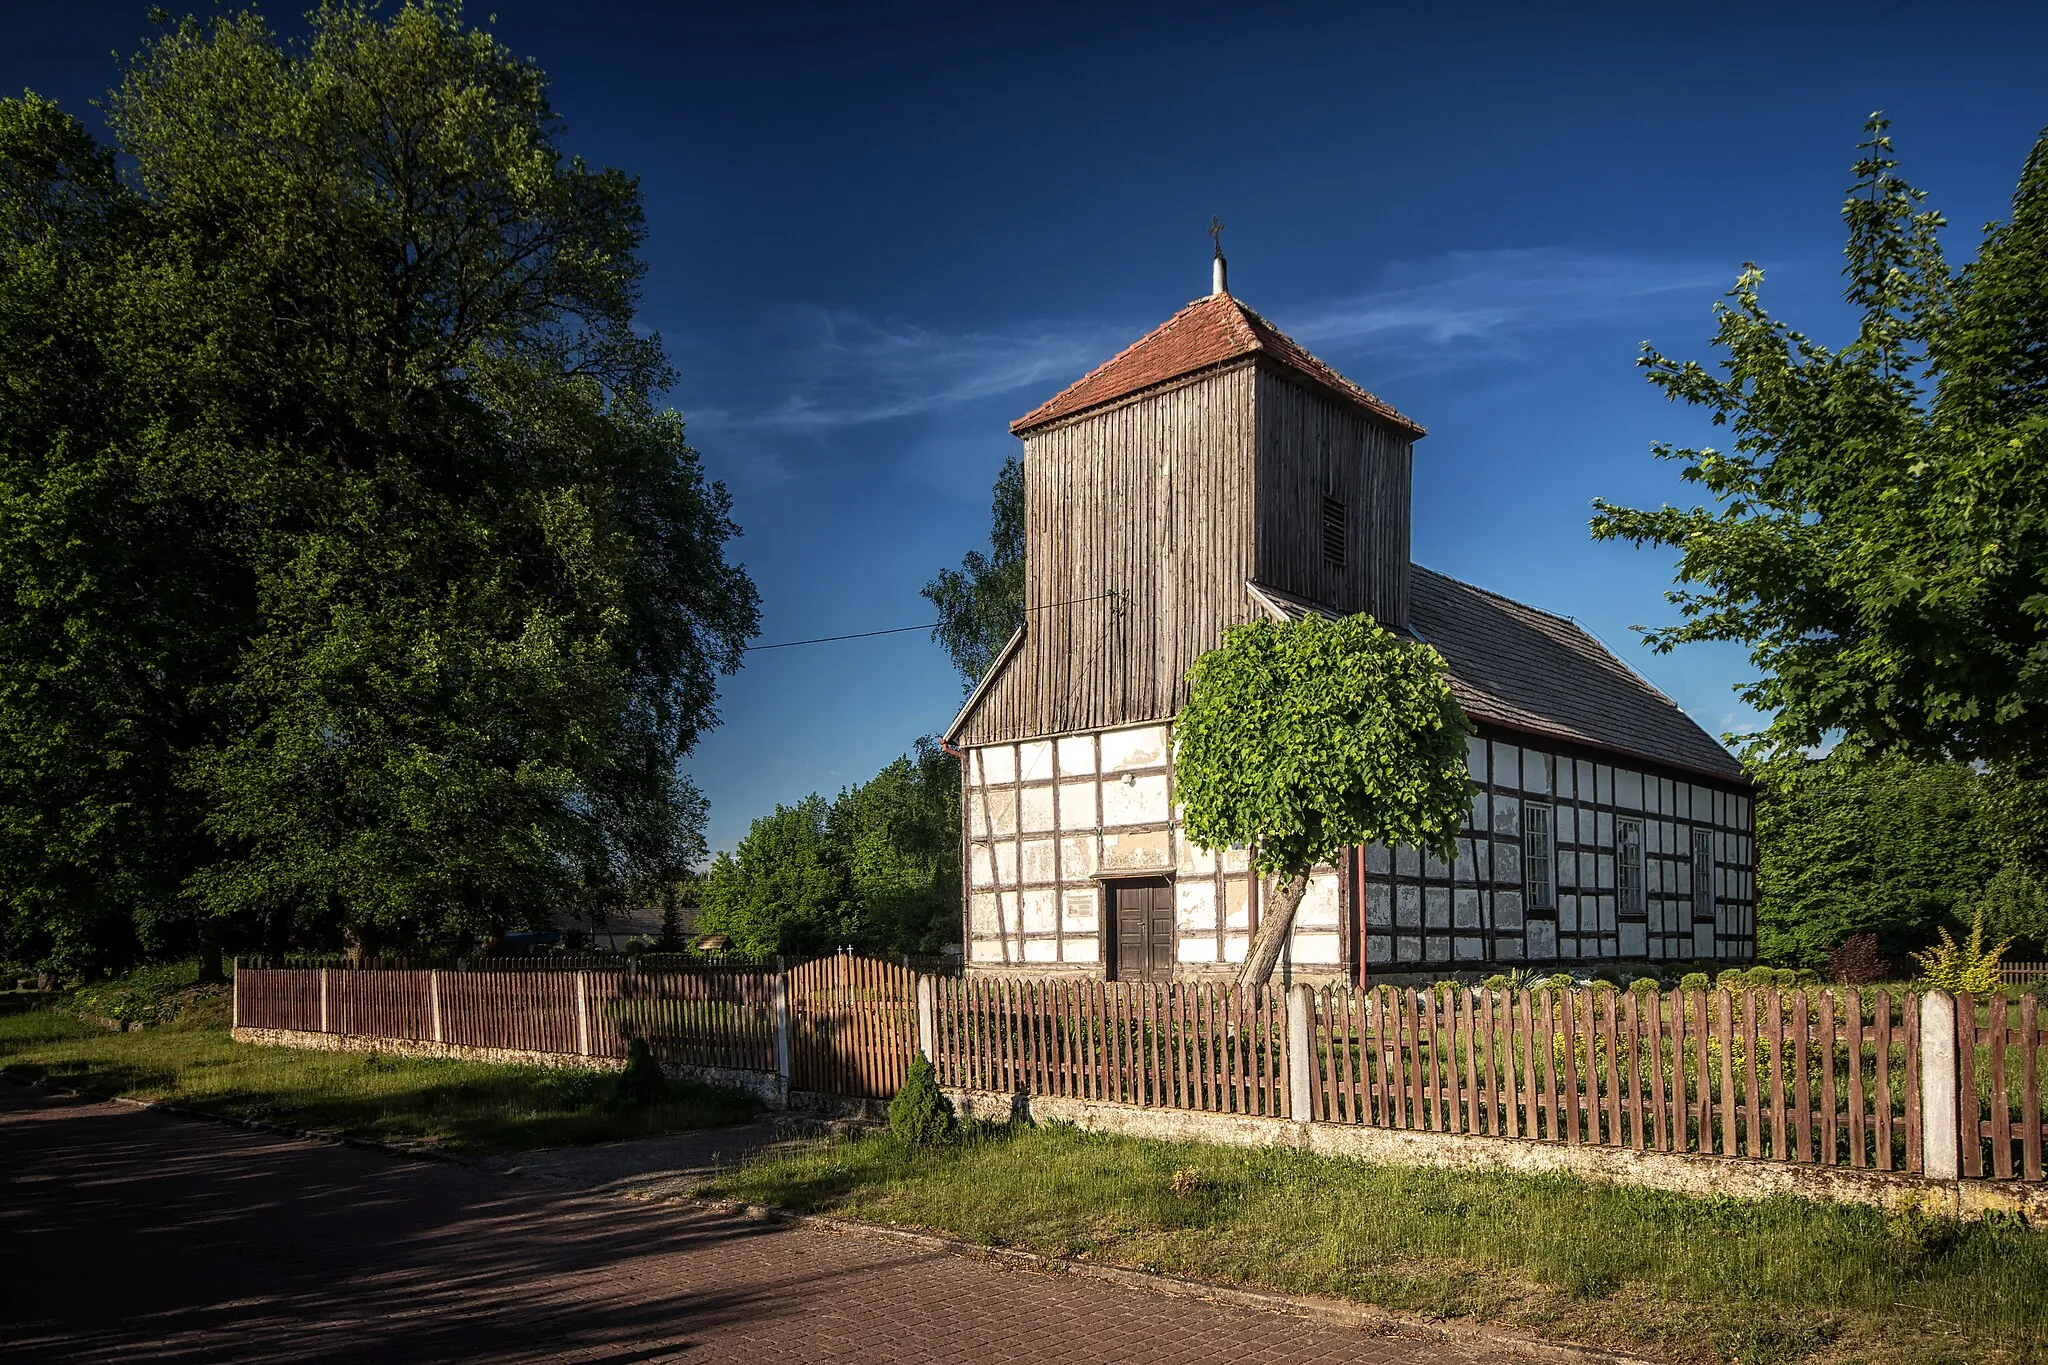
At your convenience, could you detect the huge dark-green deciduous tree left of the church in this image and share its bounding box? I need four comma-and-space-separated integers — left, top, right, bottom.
0, 0, 758, 978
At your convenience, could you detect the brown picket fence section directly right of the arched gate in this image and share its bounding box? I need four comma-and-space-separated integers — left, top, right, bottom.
932, 976, 1288, 1117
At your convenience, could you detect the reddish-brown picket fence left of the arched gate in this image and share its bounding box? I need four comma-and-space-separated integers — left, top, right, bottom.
233, 966, 776, 1072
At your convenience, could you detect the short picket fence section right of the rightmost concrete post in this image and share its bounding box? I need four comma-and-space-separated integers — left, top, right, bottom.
1956, 990, 2048, 1181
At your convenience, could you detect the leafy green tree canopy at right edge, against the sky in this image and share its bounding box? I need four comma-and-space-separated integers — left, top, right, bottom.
1593, 117, 2048, 776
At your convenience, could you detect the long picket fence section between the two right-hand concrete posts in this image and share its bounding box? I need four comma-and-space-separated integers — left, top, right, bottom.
1311, 988, 1921, 1171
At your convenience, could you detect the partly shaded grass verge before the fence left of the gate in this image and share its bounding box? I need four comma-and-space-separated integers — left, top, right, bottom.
0, 974, 760, 1154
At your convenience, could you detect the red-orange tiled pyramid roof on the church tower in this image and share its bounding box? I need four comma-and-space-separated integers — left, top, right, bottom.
1010, 295, 1425, 438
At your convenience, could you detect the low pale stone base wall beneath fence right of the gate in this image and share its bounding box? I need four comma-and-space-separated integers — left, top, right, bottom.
946, 1091, 2048, 1222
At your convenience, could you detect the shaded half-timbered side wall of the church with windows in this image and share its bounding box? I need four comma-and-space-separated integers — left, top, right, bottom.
1364, 731, 1755, 972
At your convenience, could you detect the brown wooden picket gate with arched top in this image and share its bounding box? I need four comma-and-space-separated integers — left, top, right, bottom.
788, 952, 918, 1097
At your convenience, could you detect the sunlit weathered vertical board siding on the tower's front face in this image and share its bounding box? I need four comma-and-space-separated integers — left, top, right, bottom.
954, 362, 1255, 747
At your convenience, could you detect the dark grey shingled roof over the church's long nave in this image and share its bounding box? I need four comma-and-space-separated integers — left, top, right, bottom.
1247, 565, 1743, 782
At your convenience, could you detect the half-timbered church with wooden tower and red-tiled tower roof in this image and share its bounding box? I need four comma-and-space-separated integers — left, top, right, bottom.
946, 252, 1755, 982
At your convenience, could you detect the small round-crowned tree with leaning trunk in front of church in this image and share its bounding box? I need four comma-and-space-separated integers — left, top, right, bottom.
1174, 616, 1473, 986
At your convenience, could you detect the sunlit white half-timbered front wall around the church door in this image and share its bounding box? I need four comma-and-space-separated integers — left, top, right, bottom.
961, 724, 1348, 976
